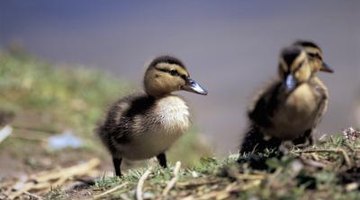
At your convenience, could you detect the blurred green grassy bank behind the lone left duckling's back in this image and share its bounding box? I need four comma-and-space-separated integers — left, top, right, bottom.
0, 51, 129, 176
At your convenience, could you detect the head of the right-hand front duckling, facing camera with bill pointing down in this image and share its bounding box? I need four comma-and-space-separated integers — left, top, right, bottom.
279, 46, 313, 91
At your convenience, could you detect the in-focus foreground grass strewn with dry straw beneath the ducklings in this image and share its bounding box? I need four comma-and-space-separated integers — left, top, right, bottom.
83, 133, 360, 200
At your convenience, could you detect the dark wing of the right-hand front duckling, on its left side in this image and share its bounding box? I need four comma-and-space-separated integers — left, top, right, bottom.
248, 81, 281, 127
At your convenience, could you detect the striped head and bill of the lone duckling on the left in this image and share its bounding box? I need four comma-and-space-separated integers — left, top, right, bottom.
144, 56, 207, 97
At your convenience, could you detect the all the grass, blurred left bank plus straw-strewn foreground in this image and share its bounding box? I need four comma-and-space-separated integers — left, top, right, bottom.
0, 51, 360, 200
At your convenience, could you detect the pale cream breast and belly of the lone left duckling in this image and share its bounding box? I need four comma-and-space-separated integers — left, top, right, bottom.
121, 96, 190, 159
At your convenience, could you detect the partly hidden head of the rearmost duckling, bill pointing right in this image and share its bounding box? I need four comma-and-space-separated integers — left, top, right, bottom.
293, 40, 334, 73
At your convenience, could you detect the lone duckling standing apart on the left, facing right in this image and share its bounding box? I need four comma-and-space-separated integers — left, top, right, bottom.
97, 56, 207, 176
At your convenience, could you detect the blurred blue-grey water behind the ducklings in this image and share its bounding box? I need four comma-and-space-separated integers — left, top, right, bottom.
0, 0, 360, 155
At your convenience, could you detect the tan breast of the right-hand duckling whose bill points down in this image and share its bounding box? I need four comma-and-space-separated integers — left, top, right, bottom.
266, 84, 326, 140
